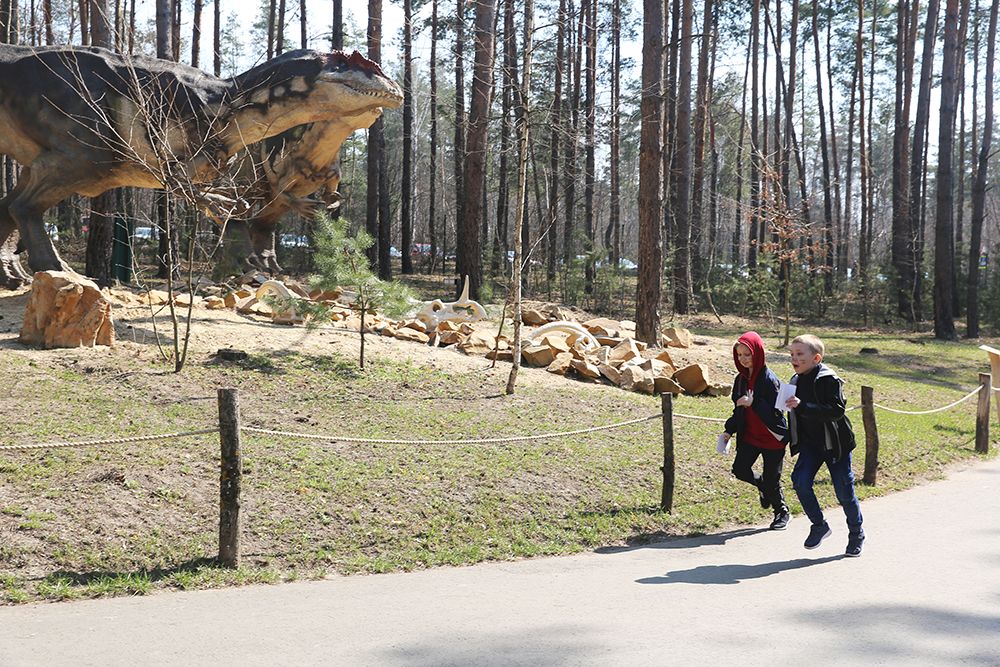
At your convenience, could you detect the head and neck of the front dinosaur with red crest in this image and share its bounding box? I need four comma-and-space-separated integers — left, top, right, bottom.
229, 49, 403, 135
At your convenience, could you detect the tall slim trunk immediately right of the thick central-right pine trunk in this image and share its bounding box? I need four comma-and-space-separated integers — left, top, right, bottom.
674, 0, 694, 314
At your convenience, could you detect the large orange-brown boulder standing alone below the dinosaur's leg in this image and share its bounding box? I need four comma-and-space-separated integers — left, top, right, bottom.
18, 271, 115, 348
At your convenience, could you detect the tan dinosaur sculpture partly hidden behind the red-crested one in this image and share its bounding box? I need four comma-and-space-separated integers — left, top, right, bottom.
226, 108, 382, 273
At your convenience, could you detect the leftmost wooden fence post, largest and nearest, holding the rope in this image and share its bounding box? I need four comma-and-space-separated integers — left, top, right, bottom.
218, 389, 243, 569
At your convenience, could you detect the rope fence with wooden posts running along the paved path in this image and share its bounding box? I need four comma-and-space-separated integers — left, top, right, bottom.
0, 373, 1000, 568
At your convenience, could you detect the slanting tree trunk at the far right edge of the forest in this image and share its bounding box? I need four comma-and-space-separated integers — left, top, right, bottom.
966, 0, 1000, 336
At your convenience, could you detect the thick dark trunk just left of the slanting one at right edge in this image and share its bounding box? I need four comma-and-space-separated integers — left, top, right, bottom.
934, 0, 959, 340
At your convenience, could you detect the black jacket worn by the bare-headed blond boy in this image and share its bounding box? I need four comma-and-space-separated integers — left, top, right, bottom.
788, 364, 856, 461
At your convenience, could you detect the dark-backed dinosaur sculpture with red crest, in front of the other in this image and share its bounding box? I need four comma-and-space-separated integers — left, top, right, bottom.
0, 45, 402, 287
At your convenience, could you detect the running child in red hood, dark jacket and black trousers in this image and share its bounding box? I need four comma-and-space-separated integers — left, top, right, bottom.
723, 331, 792, 530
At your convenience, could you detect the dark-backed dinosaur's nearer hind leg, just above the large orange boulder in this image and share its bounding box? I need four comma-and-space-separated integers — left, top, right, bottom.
8, 162, 79, 273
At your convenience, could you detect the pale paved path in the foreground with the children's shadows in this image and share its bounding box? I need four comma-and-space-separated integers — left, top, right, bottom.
0, 459, 1000, 667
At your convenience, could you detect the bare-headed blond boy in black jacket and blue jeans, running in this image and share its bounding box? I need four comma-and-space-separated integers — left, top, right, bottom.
786, 335, 865, 556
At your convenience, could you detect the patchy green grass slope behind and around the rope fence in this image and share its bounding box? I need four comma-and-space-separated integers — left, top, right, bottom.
0, 329, 996, 604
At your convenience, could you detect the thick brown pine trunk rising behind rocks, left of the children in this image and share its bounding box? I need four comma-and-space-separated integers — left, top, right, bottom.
635, 0, 666, 347
